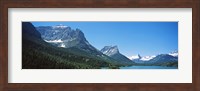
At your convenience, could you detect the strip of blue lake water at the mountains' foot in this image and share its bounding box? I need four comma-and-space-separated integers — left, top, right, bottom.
120, 66, 178, 69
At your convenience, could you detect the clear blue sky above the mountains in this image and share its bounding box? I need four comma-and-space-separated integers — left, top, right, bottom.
32, 22, 178, 57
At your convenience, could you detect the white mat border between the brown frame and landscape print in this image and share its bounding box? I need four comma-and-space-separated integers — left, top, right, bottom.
8, 8, 192, 83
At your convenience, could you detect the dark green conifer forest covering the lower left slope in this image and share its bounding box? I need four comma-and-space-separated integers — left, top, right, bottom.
22, 36, 112, 69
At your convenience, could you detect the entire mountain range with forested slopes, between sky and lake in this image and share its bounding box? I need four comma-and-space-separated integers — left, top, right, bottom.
22, 22, 178, 69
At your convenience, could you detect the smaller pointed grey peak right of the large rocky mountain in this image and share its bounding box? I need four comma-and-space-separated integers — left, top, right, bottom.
101, 46, 134, 65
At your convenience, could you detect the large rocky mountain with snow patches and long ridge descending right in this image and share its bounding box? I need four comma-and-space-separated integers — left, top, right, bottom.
36, 25, 134, 66
